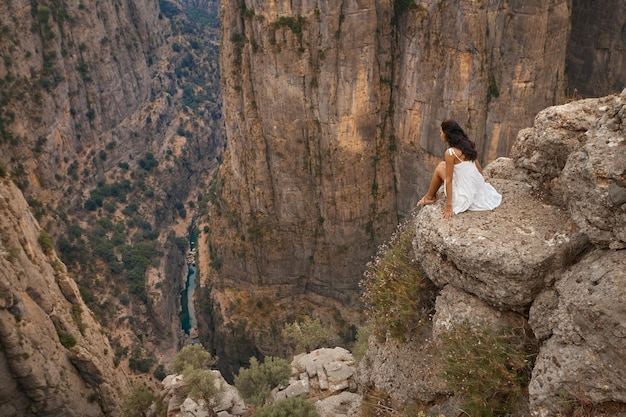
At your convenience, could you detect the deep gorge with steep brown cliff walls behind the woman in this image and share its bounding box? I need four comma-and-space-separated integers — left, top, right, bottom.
0, 0, 626, 416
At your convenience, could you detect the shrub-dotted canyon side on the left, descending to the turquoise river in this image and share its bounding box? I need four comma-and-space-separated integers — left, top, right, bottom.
0, 0, 223, 407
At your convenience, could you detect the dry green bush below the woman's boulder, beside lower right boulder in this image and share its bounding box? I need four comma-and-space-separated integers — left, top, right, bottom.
441, 322, 531, 417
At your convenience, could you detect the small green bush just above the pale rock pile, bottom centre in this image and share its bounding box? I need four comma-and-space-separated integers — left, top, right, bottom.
282, 316, 337, 353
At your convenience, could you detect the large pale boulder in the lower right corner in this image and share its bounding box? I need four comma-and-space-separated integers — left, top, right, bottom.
529, 250, 626, 416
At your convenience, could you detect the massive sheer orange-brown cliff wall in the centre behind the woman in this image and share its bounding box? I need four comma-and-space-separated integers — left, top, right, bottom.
204, 0, 570, 358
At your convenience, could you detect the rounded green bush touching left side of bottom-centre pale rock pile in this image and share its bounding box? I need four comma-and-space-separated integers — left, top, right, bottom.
235, 357, 297, 406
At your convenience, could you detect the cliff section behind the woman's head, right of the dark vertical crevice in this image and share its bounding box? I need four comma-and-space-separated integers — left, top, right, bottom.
394, 0, 571, 197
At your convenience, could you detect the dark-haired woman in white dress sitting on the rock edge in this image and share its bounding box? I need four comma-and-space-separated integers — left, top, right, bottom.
417, 120, 502, 219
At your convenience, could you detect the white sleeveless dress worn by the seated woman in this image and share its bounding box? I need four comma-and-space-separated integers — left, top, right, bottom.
444, 148, 502, 214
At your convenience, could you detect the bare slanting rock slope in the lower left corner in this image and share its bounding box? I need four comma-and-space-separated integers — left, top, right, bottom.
0, 178, 128, 417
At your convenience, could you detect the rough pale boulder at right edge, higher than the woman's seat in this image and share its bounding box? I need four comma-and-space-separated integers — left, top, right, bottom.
512, 92, 626, 249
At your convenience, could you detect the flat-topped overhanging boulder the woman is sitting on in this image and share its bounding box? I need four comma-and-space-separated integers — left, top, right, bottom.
414, 179, 586, 311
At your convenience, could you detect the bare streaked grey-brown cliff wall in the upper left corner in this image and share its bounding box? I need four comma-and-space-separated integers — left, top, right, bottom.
0, 1, 167, 180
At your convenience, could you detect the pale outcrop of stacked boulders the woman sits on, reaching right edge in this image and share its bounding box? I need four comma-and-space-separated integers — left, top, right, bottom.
359, 91, 626, 417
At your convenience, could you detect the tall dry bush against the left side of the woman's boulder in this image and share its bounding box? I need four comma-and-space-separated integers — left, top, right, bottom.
361, 216, 434, 341
